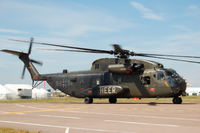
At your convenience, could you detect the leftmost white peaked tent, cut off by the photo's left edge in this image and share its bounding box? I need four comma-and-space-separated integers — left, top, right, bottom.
0, 84, 18, 100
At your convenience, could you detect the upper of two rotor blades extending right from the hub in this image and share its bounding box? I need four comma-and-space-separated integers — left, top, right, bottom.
134, 53, 200, 58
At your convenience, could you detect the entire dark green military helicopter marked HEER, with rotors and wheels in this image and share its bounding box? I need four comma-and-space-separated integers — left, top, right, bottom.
1, 38, 200, 104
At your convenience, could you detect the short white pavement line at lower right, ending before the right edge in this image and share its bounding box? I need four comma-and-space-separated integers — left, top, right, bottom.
105, 120, 179, 127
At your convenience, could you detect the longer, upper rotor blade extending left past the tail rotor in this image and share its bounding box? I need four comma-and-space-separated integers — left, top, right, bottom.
9, 39, 113, 54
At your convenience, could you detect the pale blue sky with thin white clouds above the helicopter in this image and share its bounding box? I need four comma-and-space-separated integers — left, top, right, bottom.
0, 0, 200, 86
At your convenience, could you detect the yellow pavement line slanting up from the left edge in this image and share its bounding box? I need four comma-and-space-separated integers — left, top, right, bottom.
0, 108, 81, 115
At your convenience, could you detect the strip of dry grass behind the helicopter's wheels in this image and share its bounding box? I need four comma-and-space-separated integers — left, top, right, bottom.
0, 96, 200, 103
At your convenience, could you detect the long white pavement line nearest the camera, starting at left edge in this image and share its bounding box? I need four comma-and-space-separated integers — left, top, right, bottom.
0, 120, 136, 133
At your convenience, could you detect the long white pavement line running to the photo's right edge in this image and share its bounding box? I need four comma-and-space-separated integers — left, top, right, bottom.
62, 110, 200, 121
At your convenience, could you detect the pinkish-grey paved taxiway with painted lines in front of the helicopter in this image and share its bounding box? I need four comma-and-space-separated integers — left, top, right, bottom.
0, 103, 200, 133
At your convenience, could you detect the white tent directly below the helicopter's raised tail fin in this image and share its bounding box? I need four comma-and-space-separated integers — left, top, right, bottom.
32, 88, 51, 98
